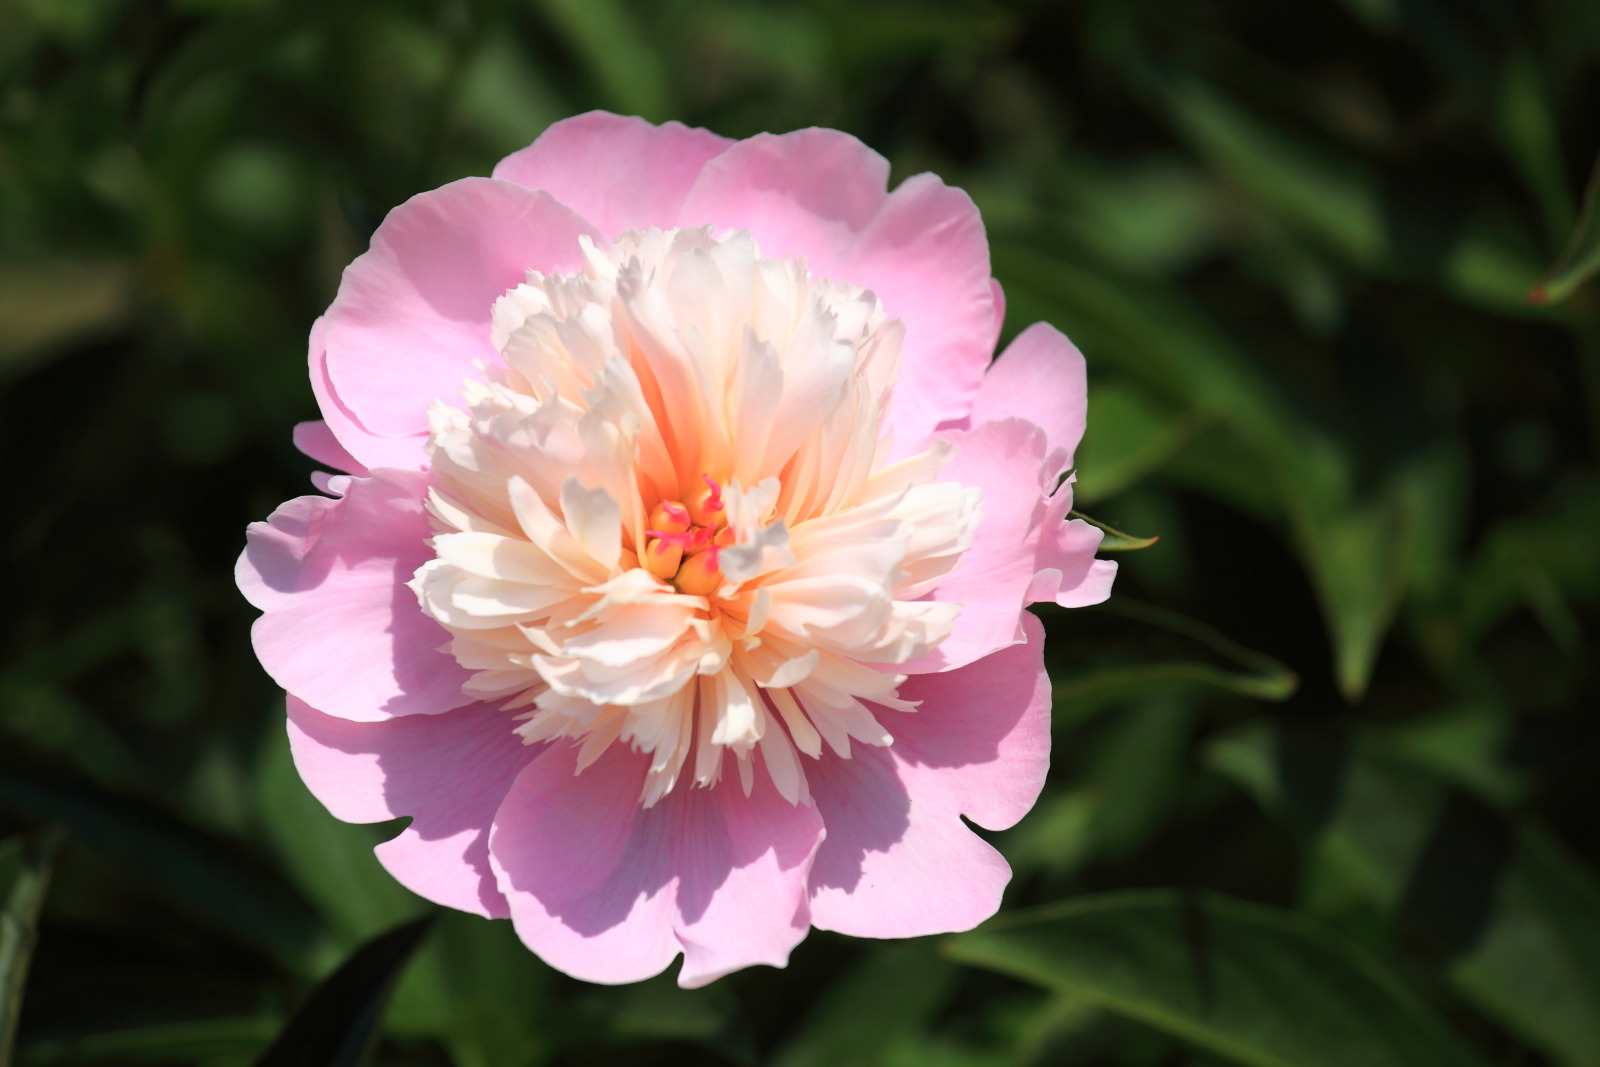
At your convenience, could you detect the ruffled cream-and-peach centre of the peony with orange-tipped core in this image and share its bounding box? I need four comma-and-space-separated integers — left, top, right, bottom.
411, 229, 978, 805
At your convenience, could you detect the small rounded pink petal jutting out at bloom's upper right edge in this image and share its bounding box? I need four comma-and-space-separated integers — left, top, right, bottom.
971, 322, 1088, 467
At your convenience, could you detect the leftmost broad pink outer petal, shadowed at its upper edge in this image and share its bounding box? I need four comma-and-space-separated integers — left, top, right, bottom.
235, 470, 469, 721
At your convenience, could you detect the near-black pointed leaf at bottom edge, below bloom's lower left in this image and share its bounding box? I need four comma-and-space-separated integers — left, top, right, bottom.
256, 917, 432, 1067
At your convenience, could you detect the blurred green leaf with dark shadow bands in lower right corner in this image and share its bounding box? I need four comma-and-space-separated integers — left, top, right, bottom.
1208, 723, 1600, 1067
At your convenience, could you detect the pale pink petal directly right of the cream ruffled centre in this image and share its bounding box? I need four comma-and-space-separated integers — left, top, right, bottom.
901, 419, 1046, 673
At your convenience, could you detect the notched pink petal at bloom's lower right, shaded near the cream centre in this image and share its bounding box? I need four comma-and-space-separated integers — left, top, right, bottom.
808, 614, 1050, 937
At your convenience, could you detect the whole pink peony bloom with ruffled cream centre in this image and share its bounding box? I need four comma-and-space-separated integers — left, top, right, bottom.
238, 114, 1115, 985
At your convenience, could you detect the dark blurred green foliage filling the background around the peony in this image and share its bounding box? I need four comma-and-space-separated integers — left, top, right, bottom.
0, 0, 1600, 1067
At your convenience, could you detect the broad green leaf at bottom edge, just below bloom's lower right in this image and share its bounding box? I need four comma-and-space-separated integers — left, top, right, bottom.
947, 889, 1482, 1067
